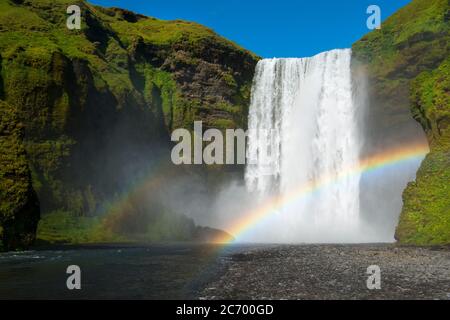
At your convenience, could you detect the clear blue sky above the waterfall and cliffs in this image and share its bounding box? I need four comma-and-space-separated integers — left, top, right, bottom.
89, 0, 410, 58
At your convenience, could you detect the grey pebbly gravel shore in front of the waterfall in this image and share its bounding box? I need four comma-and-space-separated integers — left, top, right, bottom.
200, 244, 450, 300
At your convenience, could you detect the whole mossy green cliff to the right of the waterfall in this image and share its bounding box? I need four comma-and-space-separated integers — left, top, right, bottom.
353, 0, 450, 244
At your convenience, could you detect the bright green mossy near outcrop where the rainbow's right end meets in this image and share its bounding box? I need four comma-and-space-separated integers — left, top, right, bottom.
396, 59, 450, 244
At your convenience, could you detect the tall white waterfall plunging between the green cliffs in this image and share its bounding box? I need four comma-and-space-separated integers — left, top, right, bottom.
245, 49, 362, 243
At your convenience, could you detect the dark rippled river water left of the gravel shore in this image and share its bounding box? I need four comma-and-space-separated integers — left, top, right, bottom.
0, 244, 246, 299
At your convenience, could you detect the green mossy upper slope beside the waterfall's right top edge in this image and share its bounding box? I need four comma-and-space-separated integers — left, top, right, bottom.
353, 0, 449, 79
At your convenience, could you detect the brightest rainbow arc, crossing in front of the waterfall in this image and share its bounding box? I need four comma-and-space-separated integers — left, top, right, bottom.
214, 143, 429, 244
